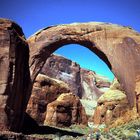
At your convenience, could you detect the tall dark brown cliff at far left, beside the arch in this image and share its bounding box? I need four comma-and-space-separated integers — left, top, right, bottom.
0, 19, 30, 131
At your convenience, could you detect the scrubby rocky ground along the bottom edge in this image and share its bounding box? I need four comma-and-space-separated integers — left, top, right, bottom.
0, 119, 140, 140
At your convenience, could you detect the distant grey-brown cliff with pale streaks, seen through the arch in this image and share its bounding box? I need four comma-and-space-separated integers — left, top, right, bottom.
41, 55, 110, 100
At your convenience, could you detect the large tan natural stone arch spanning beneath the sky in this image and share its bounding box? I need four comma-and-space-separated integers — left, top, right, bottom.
28, 22, 140, 107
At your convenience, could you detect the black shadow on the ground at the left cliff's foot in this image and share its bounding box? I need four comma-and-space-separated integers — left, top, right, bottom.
22, 113, 83, 137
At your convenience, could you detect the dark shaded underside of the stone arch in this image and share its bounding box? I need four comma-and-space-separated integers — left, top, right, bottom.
30, 39, 112, 82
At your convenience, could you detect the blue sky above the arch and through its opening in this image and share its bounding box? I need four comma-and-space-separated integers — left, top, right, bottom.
0, 0, 140, 79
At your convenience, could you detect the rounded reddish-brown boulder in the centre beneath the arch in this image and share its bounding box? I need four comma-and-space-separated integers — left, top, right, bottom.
44, 93, 87, 126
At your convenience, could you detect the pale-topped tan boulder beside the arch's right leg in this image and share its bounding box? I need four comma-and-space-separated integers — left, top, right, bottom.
93, 79, 130, 124
